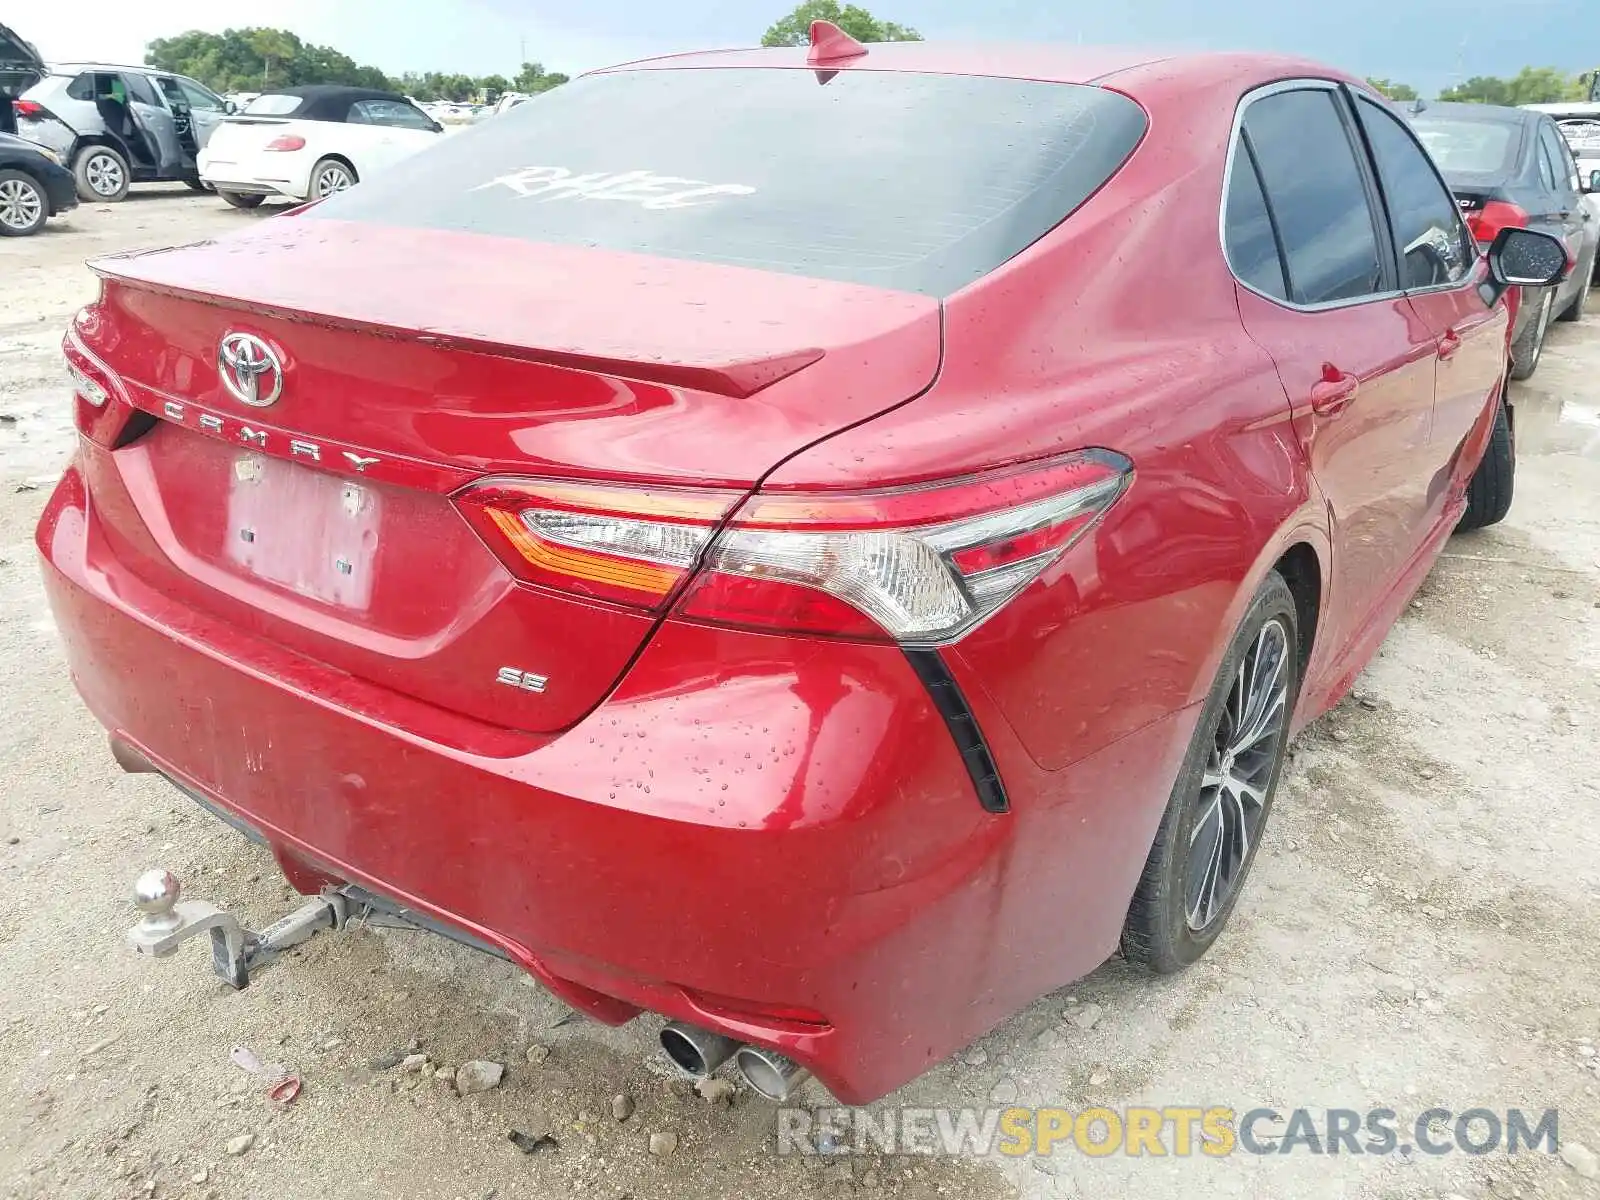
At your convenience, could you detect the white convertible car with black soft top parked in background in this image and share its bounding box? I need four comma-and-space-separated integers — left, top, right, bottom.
198, 83, 443, 208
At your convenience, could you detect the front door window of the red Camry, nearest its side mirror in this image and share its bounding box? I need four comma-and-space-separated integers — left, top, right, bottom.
1355, 96, 1477, 288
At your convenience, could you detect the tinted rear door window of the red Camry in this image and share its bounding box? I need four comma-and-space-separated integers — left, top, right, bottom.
1243, 88, 1387, 306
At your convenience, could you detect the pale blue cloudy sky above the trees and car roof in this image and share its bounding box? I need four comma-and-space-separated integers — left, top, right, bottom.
15, 0, 1600, 94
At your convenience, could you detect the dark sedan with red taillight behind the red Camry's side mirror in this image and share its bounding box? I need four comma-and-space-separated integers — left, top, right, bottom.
1405, 101, 1600, 379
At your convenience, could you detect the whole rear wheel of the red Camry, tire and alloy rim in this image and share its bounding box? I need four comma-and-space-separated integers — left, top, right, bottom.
1122, 571, 1299, 973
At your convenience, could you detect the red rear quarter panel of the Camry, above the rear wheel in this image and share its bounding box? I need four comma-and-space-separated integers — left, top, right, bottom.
763, 59, 1325, 770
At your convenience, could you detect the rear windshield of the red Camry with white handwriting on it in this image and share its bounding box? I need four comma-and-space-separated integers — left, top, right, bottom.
307, 67, 1146, 296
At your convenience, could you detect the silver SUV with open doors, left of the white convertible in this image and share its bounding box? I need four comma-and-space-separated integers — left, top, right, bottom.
16, 62, 230, 202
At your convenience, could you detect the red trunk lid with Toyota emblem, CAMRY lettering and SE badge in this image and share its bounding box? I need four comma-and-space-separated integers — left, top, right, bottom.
77, 218, 939, 731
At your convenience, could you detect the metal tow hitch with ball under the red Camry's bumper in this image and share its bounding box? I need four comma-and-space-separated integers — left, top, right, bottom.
128, 870, 353, 987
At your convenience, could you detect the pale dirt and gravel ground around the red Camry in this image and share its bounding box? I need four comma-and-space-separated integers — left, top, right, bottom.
0, 192, 1600, 1200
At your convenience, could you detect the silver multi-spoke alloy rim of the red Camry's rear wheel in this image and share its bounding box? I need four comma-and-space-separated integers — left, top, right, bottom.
1184, 618, 1291, 933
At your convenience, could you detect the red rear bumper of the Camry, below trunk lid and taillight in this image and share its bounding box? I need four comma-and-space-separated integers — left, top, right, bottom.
37, 448, 1192, 1104
